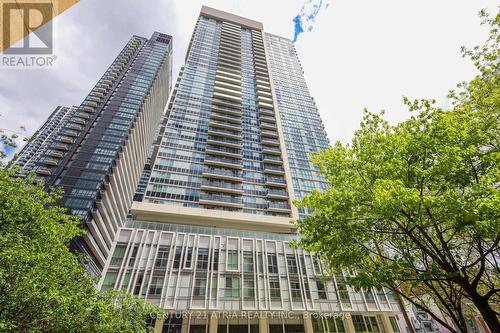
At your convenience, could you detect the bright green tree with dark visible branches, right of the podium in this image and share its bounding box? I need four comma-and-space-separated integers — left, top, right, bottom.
297, 12, 500, 332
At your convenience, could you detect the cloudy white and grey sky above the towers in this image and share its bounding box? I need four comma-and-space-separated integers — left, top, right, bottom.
0, 0, 497, 154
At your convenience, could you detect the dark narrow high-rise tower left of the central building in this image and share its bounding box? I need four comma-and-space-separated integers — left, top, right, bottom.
15, 32, 172, 274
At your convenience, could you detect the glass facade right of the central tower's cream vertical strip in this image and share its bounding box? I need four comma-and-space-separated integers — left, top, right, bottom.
265, 33, 329, 217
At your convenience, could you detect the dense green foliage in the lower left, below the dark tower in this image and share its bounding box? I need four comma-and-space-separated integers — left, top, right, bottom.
0, 168, 161, 332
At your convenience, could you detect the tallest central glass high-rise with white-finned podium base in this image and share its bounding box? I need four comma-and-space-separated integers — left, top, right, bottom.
99, 7, 405, 333
